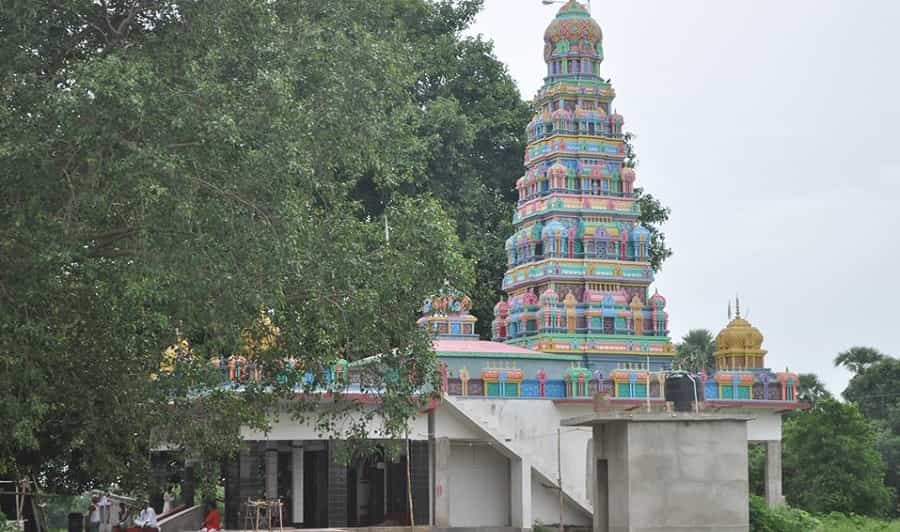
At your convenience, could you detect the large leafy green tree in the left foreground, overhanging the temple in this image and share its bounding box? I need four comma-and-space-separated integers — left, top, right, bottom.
0, 0, 472, 491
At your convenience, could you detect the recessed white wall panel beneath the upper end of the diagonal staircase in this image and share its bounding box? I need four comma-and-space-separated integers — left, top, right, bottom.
450, 442, 509, 527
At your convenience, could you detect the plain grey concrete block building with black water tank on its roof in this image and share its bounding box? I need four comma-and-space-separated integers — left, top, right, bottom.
563, 412, 749, 532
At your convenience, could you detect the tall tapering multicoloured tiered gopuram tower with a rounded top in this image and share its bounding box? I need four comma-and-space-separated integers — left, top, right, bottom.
492, 0, 674, 380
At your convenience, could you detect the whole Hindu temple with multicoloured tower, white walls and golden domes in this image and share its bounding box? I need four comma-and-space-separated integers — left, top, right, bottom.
171, 0, 802, 530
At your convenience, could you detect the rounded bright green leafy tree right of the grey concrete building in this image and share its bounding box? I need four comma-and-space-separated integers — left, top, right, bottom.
783, 399, 892, 516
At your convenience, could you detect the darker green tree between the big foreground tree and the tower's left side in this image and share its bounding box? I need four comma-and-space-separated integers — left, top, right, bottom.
357, 18, 531, 337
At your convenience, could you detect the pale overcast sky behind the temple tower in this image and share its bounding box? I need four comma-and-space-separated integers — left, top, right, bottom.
468, 0, 900, 394
